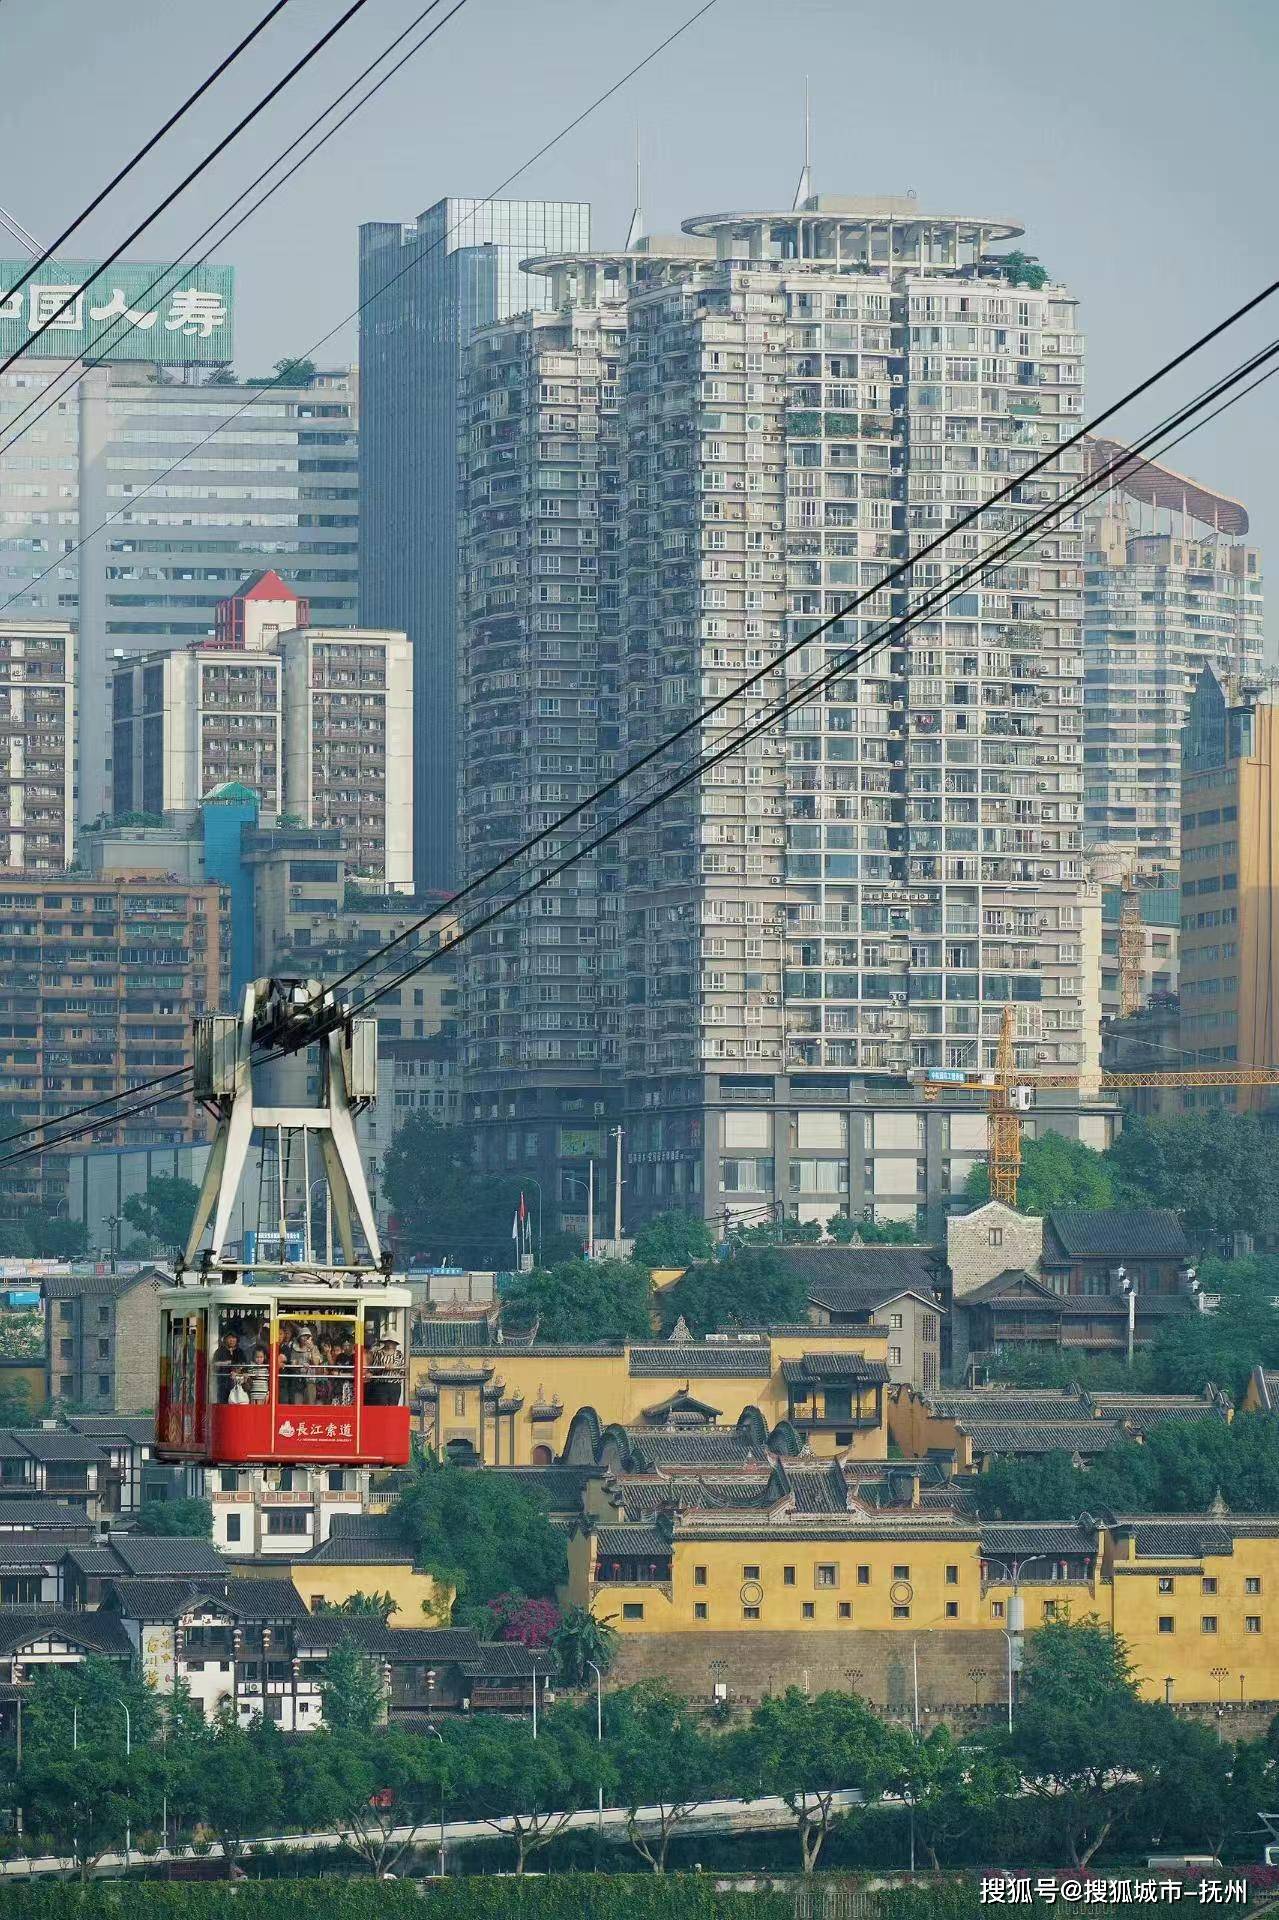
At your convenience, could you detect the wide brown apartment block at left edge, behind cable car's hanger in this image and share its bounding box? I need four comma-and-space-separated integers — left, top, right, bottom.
0, 874, 230, 1208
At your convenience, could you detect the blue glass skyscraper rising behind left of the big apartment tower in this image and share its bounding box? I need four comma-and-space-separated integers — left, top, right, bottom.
359, 200, 590, 887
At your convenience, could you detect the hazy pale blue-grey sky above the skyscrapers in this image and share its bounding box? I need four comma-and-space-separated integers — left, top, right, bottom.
0, 0, 1279, 634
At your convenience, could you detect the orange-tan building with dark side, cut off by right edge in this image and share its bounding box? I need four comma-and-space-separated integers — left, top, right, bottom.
1179, 666, 1279, 1112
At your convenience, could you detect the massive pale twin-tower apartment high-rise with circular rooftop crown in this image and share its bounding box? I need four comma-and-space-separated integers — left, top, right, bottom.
465, 196, 1100, 1217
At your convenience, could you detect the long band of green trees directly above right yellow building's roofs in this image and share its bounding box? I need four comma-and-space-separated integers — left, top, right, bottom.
974, 1413, 1279, 1521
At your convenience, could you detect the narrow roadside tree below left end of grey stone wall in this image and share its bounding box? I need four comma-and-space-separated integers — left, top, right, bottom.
605, 1682, 718, 1874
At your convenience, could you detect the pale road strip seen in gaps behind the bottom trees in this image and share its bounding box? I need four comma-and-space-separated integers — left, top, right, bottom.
0, 1788, 862, 1880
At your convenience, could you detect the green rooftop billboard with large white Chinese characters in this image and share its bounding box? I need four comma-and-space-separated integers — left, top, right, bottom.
0, 259, 234, 367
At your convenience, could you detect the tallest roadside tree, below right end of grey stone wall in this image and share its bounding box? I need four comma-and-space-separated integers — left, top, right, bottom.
1008, 1620, 1171, 1868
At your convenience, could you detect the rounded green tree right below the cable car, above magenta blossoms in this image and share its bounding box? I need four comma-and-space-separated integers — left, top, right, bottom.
396, 1463, 568, 1624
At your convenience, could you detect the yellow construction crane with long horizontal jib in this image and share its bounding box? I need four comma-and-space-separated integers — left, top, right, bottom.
910, 1006, 1279, 1206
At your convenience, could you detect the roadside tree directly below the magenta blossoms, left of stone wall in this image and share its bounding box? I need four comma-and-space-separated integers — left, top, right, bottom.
457, 1707, 615, 1874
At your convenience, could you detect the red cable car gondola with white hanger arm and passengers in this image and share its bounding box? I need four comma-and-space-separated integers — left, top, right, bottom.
156, 979, 411, 1467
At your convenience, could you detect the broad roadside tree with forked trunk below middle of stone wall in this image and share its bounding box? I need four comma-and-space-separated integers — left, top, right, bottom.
728, 1688, 910, 1874
